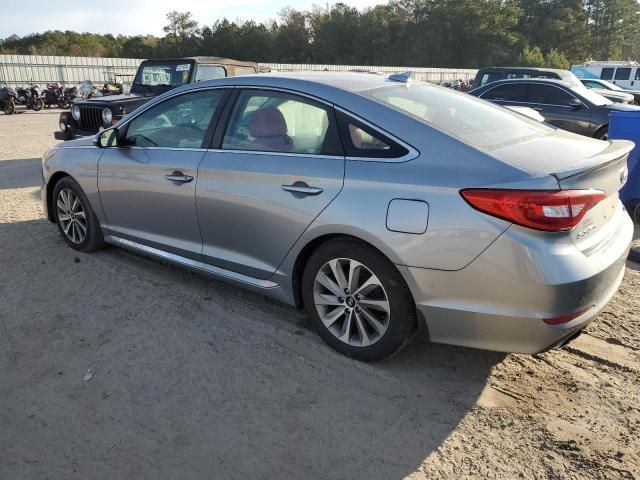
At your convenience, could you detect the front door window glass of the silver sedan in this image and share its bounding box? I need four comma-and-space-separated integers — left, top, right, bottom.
126, 90, 225, 148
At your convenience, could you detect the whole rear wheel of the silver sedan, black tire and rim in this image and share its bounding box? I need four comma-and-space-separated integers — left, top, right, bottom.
302, 239, 417, 362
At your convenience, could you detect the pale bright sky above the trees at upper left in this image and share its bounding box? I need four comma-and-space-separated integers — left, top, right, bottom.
0, 0, 385, 38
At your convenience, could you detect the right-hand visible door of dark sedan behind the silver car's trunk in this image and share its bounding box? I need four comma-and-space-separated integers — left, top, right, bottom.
526, 83, 591, 135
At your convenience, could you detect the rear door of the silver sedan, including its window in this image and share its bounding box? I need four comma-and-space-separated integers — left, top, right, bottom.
196, 89, 345, 279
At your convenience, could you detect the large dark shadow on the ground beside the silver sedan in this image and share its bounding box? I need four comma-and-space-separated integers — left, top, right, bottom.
0, 218, 504, 479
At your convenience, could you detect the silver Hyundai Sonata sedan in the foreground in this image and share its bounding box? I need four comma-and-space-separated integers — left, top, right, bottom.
42, 72, 633, 361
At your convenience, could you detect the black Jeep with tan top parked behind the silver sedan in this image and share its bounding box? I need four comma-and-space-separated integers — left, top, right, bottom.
54, 57, 259, 140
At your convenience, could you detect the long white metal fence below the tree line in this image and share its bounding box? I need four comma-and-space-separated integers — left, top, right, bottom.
0, 55, 476, 87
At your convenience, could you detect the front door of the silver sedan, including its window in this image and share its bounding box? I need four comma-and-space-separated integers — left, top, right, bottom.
98, 89, 226, 259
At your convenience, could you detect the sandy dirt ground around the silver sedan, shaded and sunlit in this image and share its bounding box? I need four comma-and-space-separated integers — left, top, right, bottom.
0, 112, 640, 480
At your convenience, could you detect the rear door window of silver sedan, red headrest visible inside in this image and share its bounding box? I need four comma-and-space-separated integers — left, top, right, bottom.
222, 90, 338, 155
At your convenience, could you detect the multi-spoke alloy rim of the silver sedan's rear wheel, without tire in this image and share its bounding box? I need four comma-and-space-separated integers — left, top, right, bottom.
313, 258, 391, 347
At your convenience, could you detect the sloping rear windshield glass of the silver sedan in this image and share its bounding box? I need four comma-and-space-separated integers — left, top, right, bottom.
362, 83, 553, 150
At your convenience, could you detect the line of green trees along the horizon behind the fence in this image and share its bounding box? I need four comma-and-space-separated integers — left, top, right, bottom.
0, 0, 640, 68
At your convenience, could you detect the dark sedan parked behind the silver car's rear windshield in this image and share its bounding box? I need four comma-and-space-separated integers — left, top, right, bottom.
469, 79, 640, 140
